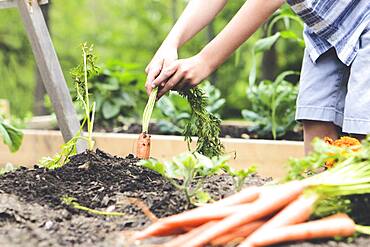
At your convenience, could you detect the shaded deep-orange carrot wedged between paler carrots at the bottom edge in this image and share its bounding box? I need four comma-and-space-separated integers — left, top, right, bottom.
211, 220, 265, 246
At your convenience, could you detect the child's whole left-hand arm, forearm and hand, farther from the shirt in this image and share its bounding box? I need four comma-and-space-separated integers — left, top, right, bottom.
145, 0, 227, 93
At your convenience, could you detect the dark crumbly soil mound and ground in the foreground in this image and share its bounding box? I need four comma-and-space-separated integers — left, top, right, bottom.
0, 150, 370, 247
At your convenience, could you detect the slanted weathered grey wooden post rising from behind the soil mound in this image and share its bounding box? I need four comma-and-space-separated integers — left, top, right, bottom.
17, 0, 86, 151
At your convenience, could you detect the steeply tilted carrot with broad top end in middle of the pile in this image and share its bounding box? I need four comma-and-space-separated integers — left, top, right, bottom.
246, 194, 318, 242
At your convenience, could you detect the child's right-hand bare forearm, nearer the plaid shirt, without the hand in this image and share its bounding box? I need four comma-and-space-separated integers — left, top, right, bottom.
200, 0, 285, 70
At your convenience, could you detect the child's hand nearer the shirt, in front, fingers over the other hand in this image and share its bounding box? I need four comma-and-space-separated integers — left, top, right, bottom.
152, 54, 213, 99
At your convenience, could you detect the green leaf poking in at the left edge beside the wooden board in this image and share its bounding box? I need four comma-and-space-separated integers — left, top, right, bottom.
0, 114, 23, 152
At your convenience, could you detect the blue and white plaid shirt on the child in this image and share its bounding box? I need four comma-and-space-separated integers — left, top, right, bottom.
287, 0, 370, 65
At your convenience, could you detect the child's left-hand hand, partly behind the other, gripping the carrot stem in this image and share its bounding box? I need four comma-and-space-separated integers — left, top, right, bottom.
145, 46, 178, 95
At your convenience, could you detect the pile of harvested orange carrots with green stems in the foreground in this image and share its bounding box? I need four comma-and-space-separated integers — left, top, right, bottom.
135, 136, 370, 247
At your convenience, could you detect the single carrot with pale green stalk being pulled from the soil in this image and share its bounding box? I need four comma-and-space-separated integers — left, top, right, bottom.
136, 88, 158, 159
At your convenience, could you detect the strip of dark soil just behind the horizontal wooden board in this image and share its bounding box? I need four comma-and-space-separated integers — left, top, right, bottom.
98, 123, 303, 141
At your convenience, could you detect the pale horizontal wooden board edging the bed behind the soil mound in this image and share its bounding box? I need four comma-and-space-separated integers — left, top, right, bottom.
0, 130, 304, 178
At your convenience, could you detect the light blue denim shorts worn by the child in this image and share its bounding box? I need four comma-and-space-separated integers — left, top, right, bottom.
296, 29, 370, 134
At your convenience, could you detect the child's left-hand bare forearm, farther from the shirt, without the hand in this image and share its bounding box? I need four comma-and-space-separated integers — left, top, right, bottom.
163, 0, 227, 48
